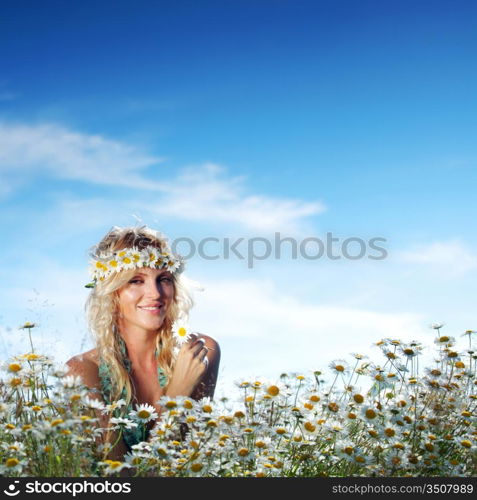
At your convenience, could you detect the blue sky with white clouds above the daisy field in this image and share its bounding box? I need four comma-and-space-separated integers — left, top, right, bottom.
0, 0, 477, 390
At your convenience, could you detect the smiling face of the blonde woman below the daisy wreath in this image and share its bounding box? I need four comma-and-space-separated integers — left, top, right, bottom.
118, 268, 174, 333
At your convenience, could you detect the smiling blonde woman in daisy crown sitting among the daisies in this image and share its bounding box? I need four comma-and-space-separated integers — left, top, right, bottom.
67, 226, 220, 458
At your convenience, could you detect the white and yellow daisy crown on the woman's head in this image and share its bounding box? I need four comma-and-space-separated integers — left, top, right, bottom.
85, 246, 185, 288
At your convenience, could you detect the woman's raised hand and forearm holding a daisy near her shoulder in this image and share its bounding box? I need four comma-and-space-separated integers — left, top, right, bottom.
166, 334, 209, 397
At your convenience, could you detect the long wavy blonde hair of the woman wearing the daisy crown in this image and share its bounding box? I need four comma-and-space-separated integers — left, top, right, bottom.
86, 226, 194, 404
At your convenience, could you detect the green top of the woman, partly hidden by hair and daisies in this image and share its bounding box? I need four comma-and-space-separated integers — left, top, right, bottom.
98, 337, 167, 451
